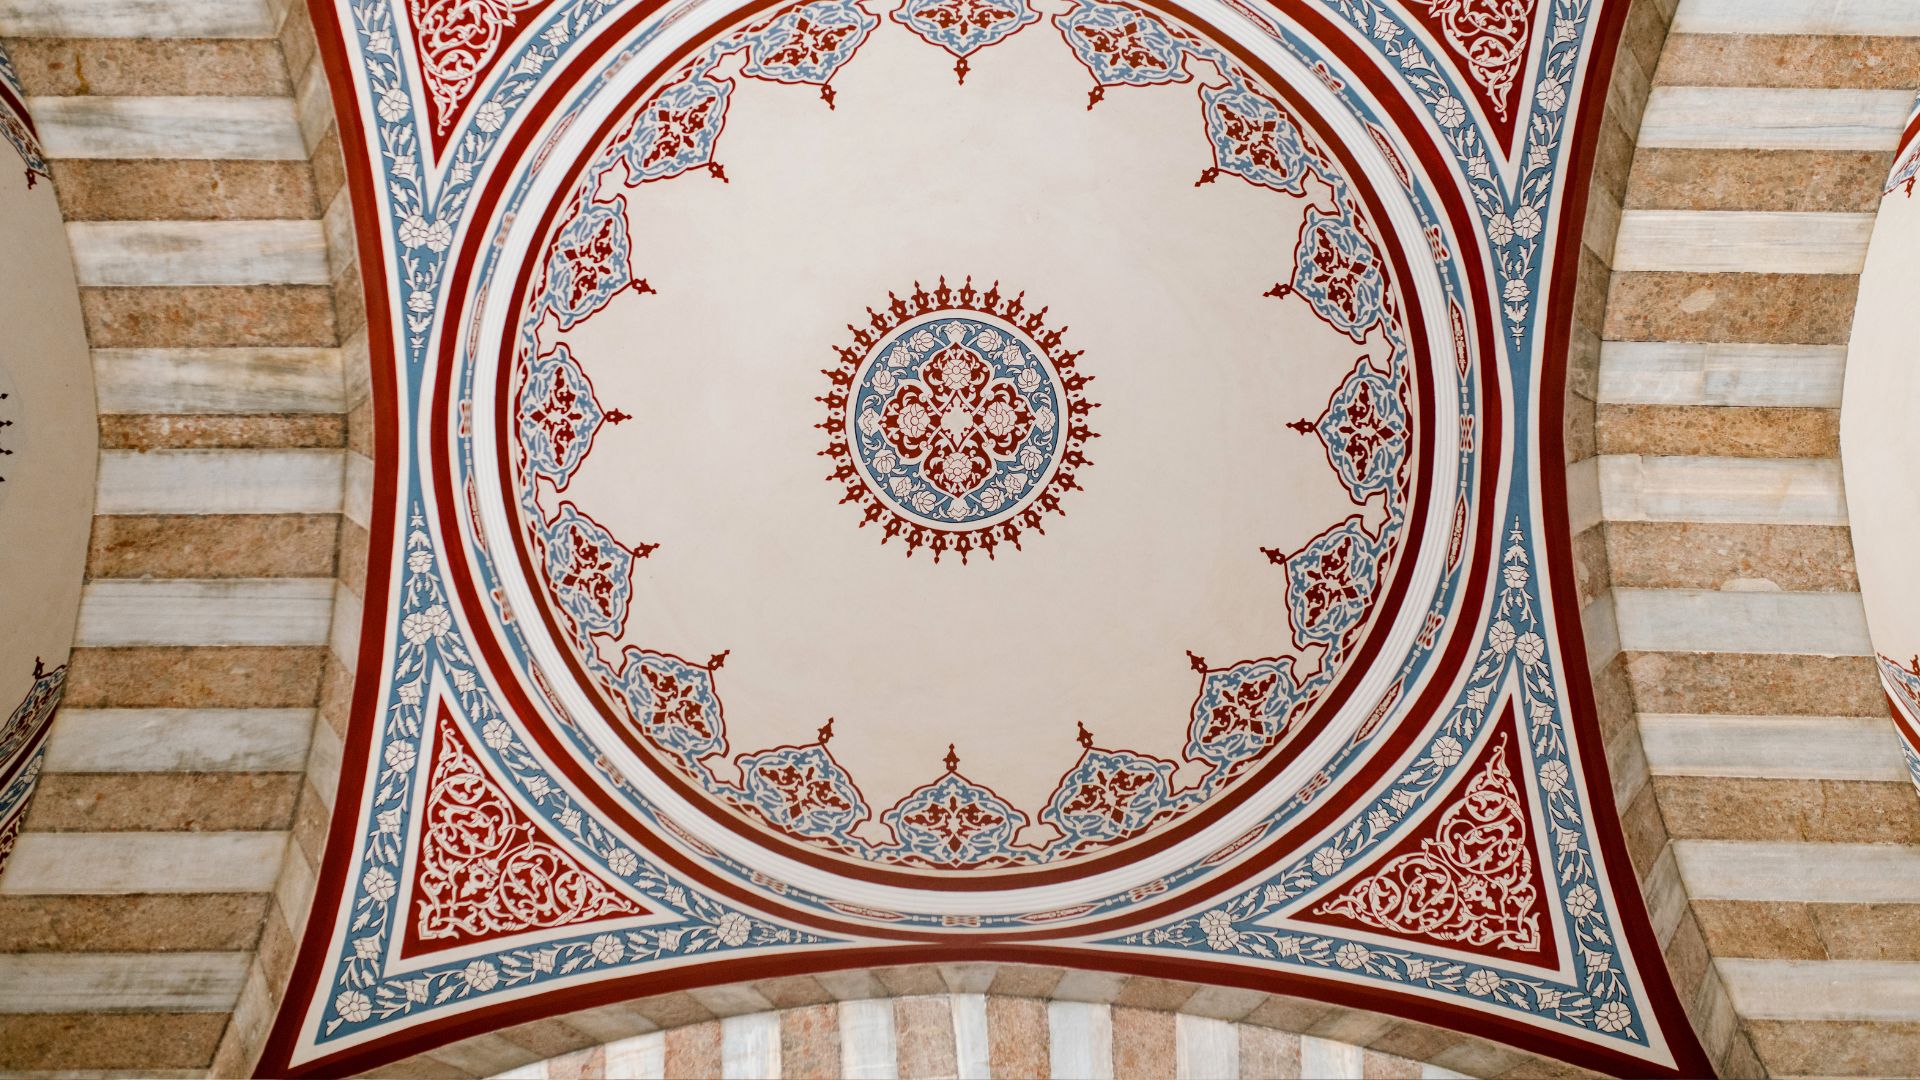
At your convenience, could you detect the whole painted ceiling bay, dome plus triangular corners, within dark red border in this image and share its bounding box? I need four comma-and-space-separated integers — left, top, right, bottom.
263, 0, 1707, 1074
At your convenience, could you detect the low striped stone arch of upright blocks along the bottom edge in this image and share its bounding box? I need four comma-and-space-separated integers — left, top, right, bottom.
366, 963, 1592, 1080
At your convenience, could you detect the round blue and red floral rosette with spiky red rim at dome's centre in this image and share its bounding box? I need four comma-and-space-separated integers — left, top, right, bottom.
822, 279, 1094, 561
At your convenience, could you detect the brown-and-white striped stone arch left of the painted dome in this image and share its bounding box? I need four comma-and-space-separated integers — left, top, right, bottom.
0, 0, 371, 1076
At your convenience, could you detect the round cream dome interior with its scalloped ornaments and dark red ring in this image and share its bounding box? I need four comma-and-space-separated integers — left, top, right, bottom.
474, 0, 1467, 911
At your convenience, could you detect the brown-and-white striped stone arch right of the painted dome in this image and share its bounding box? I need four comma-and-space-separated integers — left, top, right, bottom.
1569, 0, 1920, 1076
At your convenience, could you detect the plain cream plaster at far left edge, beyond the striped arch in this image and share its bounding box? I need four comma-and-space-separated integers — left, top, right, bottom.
0, 164, 100, 699
